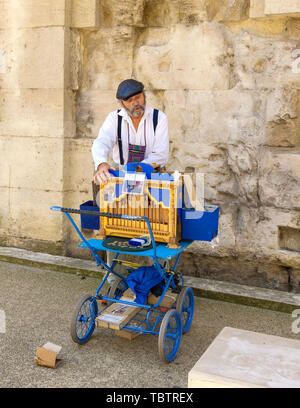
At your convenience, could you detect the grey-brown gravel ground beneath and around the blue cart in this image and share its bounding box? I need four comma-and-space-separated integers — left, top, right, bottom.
0, 262, 300, 388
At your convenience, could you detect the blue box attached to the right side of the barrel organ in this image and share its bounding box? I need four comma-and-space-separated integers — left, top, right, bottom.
181, 205, 220, 241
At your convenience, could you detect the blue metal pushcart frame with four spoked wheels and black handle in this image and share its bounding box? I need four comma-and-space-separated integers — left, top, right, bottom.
51, 206, 194, 362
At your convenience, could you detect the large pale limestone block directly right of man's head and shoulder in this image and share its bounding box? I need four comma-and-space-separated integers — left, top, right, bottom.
164, 90, 265, 156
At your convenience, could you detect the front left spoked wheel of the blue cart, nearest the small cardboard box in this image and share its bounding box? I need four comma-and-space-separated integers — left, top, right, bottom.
71, 295, 98, 344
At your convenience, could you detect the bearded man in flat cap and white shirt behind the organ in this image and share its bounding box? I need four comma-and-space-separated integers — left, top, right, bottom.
92, 79, 169, 183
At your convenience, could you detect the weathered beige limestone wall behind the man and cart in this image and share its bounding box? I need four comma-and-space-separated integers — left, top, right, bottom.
0, 0, 300, 291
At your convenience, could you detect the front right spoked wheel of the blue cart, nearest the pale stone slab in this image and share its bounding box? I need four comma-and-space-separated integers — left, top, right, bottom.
158, 309, 182, 363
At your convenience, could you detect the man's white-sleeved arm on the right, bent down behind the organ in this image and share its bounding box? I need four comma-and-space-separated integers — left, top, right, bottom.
142, 112, 169, 166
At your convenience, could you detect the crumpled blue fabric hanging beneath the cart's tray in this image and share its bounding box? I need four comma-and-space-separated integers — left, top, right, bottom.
126, 266, 163, 304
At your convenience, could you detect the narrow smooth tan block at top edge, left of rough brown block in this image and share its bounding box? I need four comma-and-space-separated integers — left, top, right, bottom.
71, 0, 100, 28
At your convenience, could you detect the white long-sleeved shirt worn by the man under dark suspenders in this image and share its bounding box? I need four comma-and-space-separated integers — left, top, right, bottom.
92, 106, 169, 170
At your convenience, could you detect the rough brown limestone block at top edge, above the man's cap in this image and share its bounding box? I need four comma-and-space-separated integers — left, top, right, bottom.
101, 0, 145, 27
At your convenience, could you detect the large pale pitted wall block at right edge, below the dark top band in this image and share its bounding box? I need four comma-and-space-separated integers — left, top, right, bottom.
234, 31, 300, 89
